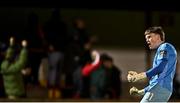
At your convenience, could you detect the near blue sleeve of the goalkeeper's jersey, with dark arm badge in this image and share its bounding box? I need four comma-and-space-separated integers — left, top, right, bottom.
146, 45, 169, 78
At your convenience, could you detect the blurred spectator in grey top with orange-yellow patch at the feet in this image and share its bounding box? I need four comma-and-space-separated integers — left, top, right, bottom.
47, 44, 64, 99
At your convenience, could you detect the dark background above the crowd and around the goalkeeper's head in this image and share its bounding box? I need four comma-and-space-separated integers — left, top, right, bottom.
0, 0, 180, 48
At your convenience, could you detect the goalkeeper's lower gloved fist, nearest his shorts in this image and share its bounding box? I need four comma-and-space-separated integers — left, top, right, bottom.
129, 87, 145, 96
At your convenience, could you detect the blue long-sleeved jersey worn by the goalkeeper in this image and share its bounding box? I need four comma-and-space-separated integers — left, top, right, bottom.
145, 43, 177, 92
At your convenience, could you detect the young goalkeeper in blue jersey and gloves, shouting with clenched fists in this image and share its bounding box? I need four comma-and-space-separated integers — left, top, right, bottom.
127, 27, 177, 103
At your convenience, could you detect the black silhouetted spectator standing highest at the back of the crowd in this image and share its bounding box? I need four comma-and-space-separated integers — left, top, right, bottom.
43, 8, 67, 52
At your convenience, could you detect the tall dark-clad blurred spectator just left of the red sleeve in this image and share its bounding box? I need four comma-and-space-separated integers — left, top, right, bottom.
63, 18, 95, 98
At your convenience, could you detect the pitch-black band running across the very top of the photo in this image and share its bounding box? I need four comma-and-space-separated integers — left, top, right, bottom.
0, 0, 180, 11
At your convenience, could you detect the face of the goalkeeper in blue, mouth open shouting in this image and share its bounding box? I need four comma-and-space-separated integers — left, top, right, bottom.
145, 33, 163, 49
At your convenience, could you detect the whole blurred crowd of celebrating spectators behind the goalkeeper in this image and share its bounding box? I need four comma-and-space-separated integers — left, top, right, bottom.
0, 9, 122, 100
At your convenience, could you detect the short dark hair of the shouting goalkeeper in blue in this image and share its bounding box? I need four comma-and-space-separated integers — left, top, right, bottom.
144, 26, 165, 41
